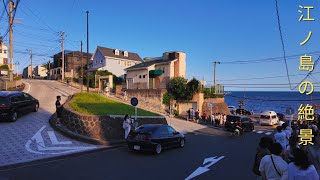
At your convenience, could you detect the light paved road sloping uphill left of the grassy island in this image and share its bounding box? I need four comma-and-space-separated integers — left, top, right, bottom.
0, 80, 99, 169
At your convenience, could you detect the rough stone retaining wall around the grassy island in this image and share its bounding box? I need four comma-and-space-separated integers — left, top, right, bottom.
61, 98, 167, 142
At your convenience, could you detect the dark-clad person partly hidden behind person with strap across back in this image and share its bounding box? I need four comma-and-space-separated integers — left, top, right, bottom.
252, 137, 273, 176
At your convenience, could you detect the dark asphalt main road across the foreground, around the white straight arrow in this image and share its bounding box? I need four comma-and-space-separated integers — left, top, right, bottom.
0, 127, 276, 180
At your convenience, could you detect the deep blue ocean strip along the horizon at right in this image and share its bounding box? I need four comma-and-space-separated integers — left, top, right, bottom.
225, 91, 320, 113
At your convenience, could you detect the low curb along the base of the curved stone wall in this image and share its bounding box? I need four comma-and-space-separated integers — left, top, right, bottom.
49, 114, 126, 146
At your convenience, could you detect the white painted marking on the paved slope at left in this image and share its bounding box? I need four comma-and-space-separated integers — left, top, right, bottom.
25, 126, 96, 154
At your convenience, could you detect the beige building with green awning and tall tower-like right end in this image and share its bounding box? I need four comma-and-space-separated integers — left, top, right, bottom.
125, 52, 186, 89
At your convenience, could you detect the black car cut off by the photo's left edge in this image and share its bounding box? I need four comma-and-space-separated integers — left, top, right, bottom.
0, 91, 39, 122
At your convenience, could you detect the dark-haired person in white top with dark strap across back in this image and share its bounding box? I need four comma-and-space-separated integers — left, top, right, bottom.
259, 143, 288, 180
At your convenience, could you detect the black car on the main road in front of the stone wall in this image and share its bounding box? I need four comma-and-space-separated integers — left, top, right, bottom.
127, 124, 185, 154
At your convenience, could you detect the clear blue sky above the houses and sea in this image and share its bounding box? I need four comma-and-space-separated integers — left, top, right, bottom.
0, 0, 320, 91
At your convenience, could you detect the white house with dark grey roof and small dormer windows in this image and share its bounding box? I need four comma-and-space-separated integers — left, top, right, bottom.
89, 46, 143, 77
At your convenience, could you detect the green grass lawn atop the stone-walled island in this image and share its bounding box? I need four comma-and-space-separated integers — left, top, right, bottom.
70, 93, 159, 116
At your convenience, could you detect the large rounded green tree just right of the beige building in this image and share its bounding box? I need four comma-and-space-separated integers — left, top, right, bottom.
168, 77, 187, 100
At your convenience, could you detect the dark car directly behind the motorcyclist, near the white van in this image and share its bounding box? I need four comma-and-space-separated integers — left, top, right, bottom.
224, 115, 254, 132
